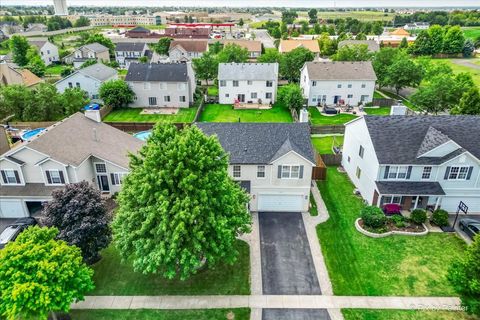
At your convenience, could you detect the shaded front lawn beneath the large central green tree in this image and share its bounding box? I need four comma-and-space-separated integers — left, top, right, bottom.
90, 240, 250, 296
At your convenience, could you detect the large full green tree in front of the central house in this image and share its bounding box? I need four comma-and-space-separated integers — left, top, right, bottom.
113, 124, 251, 279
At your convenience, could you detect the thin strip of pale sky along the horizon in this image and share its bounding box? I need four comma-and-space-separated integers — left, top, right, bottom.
0, 0, 480, 8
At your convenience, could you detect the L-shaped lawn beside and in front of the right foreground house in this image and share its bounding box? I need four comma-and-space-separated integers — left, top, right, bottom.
317, 167, 466, 296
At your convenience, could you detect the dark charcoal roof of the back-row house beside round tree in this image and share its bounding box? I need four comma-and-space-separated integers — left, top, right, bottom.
125, 63, 188, 82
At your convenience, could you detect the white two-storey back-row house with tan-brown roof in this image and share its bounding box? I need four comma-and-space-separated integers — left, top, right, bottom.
300, 61, 377, 106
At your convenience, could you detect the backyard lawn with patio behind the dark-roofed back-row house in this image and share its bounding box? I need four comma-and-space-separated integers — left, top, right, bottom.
103, 107, 197, 123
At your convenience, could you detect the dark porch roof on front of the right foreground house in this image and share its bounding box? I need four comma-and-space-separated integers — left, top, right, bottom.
375, 181, 445, 196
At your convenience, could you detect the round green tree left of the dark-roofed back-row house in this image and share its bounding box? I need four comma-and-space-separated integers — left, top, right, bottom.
98, 79, 135, 108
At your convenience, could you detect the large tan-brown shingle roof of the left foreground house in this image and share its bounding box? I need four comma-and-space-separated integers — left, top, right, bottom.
17, 112, 143, 168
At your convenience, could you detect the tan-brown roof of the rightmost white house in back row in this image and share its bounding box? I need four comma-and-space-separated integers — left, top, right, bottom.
304, 61, 377, 81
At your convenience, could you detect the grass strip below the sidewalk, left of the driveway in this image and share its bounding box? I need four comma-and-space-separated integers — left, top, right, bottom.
70, 308, 250, 320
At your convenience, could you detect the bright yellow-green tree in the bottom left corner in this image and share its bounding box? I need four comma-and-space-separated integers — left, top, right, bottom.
0, 226, 94, 320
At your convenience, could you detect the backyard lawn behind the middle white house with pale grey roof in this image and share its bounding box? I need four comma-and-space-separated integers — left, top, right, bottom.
200, 102, 292, 122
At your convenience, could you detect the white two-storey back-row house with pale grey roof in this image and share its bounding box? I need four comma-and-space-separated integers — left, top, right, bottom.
218, 63, 278, 104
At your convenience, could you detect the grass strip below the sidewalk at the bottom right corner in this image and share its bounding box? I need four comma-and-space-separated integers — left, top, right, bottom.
342, 309, 475, 320
